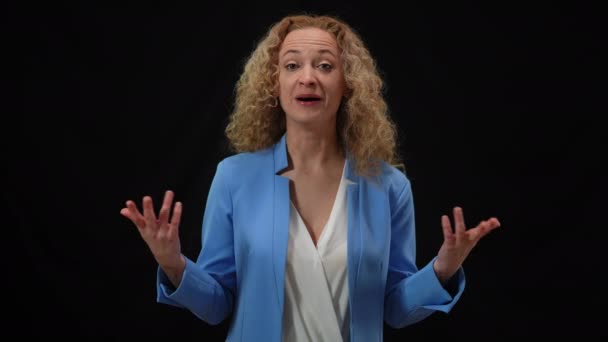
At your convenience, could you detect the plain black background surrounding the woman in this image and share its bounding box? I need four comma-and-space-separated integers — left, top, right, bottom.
9, 1, 608, 341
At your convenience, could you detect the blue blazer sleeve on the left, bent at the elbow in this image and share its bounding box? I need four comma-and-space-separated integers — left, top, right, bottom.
157, 162, 236, 324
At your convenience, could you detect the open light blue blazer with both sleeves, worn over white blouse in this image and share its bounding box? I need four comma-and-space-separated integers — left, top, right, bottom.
157, 134, 465, 342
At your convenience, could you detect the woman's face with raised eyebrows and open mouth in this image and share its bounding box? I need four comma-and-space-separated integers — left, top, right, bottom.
279, 28, 345, 124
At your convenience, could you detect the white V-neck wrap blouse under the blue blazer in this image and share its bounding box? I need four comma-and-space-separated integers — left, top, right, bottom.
282, 165, 350, 342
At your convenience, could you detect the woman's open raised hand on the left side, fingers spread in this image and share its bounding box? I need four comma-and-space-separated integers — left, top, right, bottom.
120, 190, 186, 272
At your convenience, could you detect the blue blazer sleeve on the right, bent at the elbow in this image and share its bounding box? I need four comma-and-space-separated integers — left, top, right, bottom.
384, 180, 465, 328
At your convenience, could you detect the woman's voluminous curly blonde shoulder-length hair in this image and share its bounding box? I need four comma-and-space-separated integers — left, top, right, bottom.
226, 15, 403, 176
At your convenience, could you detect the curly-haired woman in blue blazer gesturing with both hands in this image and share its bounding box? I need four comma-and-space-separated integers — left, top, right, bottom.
121, 16, 499, 341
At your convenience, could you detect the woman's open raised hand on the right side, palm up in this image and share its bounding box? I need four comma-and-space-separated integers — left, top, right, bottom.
433, 207, 500, 284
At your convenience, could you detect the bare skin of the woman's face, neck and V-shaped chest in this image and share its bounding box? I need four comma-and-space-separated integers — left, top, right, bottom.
279, 28, 346, 245
